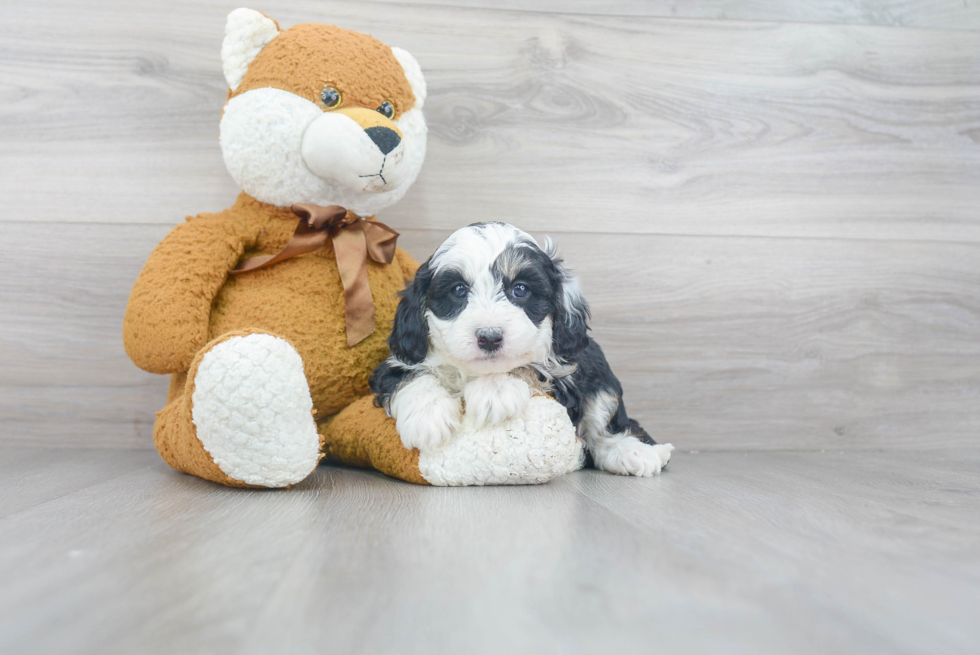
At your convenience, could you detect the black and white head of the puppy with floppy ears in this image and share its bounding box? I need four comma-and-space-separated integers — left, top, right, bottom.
388, 223, 589, 375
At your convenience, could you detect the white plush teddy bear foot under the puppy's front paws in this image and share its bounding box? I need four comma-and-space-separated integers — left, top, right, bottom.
419, 396, 585, 487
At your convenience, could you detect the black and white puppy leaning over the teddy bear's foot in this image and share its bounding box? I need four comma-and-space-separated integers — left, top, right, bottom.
371, 223, 673, 476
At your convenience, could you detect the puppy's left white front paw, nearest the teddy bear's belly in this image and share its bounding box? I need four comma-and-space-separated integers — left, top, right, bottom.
389, 375, 461, 451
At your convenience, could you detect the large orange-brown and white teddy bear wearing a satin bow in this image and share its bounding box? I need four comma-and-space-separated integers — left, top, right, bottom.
123, 8, 584, 488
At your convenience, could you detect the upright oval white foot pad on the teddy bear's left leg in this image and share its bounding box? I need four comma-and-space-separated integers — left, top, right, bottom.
192, 334, 320, 487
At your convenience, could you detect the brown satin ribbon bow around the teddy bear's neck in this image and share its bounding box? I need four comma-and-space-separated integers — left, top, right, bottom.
231, 202, 398, 348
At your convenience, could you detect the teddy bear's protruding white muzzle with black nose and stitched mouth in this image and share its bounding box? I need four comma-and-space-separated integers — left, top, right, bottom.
302, 107, 407, 193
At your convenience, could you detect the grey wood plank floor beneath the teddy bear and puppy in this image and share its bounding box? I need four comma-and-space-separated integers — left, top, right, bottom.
0, 447, 980, 654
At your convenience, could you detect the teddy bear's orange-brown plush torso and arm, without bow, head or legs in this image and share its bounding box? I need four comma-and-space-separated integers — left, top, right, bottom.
123, 194, 417, 416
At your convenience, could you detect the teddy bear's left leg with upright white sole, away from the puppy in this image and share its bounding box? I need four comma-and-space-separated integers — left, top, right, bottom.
154, 331, 321, 487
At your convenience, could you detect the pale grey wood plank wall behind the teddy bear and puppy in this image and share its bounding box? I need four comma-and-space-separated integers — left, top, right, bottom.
0, 0, 980, 449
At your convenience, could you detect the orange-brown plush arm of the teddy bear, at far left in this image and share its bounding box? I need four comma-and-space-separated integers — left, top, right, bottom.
123, 217, 255, 373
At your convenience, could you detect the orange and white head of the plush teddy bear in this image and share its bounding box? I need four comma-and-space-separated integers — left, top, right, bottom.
221, 9, 426, 216
